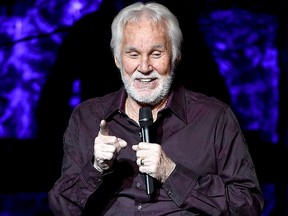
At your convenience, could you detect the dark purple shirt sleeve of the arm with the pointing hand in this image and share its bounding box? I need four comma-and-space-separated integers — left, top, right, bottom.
48, 107, 102, 216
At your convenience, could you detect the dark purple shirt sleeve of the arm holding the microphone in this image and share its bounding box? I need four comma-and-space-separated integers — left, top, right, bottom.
163, 108, 264, 216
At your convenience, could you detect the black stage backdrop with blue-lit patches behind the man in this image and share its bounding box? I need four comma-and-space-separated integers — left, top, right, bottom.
0, 0, 288, 216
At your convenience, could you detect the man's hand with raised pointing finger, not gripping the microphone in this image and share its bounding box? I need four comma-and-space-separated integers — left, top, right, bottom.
93, 120, 127, 172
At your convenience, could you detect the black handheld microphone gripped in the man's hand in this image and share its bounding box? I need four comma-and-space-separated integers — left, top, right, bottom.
139, 107, 154, 195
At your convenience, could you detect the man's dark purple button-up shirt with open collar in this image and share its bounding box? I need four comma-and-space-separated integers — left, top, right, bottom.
49, 87, 263, 216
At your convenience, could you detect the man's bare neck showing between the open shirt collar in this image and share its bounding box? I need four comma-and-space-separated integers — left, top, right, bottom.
125, 96, 167, 122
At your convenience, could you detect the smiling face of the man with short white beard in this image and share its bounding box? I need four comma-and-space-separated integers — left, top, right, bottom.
115, 17, 173, 105
